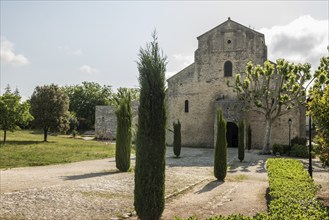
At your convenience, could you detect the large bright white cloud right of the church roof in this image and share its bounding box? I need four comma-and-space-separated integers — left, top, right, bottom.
259, 15, 329, 69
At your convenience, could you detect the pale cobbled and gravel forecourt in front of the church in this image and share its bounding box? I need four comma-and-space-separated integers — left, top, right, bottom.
0, 147, 329, 219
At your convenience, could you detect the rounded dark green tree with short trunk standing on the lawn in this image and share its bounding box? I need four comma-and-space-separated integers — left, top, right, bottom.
30, 84, 69, 141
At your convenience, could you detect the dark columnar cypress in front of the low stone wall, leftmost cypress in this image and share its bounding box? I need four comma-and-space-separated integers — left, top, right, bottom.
115, 92, 132, 172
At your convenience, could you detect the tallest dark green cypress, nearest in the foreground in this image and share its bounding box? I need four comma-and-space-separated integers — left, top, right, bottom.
134, 32, 167, 220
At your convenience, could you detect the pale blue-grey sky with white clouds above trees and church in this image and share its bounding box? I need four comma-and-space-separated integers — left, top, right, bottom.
0, 0, 329, 99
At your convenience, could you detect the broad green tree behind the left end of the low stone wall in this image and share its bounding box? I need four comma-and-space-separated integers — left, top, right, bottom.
64, 82, 112, 129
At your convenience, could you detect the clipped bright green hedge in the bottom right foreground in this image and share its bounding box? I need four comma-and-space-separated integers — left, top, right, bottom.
267, 158, 329, 220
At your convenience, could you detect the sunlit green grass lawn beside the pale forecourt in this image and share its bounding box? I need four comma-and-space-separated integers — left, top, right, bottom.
0, 130, 115, 168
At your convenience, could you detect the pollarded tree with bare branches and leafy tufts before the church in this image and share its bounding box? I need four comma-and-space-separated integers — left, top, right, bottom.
228, 59, 312, 153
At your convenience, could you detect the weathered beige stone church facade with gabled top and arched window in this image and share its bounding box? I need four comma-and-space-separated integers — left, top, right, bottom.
167, 18, 305, 148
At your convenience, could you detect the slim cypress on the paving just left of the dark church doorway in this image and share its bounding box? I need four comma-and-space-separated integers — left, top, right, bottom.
214, 109, 227, 181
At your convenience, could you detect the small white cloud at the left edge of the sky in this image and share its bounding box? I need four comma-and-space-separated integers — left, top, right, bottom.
0, 38, 30, 66
